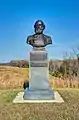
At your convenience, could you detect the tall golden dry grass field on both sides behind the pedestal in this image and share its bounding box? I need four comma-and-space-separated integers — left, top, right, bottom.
0, 66, 79, 89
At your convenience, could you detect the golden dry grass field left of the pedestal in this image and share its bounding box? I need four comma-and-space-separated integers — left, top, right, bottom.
0, 66, 29, 88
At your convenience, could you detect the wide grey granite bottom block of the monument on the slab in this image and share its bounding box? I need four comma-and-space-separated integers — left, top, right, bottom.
23, 88, 54, 100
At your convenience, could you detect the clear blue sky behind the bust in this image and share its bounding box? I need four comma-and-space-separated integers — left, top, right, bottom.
0, 0, 79, 62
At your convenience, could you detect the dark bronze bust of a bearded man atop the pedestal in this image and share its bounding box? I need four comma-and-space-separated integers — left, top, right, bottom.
27, 20, 52, 49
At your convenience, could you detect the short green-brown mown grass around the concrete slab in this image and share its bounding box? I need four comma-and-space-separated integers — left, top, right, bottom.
0, 88, 79, 120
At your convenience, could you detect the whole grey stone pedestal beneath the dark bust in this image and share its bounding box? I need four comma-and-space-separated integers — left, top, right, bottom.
24, 50, 54, 100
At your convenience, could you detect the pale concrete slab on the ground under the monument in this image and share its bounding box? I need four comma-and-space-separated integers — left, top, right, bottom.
13, 91, 64, 103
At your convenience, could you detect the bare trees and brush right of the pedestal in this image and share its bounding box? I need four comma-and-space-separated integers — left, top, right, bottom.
49, 46, 79, 79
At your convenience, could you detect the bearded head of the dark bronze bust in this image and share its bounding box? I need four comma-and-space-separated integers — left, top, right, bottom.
34, 20, 45, 34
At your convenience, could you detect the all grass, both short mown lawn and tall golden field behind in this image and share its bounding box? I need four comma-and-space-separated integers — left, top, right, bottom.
0, 66, 79, 120
